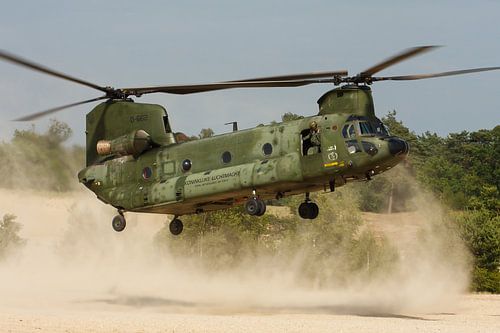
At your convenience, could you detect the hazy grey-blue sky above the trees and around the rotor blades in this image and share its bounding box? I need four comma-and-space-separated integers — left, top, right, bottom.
0, 0, 500, 145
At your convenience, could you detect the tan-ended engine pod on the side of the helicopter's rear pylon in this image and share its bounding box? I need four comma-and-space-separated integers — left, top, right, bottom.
97, 130, 151, 156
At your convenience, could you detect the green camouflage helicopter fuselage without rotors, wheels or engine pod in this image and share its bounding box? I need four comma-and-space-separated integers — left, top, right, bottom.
79, 86, 408, 215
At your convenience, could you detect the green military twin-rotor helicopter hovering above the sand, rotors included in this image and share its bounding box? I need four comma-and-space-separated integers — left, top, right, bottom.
0, 46, 500, 235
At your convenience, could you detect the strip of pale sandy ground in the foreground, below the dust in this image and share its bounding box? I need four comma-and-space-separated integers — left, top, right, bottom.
0, 295, 500, 332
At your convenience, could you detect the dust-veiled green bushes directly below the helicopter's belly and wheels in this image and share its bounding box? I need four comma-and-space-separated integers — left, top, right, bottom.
155, 189, 397, 286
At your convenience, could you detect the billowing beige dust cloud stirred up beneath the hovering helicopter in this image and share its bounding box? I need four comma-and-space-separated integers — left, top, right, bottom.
0, 183, 468, 315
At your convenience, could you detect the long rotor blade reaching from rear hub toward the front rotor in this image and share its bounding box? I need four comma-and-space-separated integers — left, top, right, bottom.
120, 78, 338, 96
